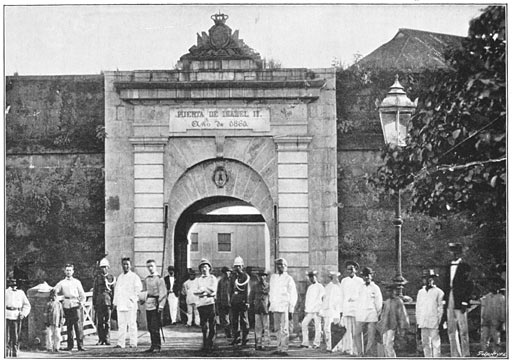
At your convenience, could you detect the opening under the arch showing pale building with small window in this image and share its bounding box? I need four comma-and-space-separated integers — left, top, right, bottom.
174, 196, 271, 275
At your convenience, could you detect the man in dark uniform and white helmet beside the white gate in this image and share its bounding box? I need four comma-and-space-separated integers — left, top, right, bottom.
92, 258, 116, 346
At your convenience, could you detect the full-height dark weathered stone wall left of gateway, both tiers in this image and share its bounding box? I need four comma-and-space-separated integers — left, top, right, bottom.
5, 75, 104, 289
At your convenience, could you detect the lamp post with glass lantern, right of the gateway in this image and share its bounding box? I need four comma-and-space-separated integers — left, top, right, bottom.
379, 75, 416, 298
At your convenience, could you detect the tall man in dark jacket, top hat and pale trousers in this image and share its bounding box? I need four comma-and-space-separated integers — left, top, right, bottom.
445, 243, 473, 357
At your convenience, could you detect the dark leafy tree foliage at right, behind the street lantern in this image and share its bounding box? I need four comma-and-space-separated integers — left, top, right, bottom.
376, 6, 506, 230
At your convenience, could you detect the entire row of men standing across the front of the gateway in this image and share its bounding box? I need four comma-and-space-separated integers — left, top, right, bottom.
5, 243, 505, 357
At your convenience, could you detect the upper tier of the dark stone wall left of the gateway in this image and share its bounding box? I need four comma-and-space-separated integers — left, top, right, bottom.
6, 75, 104, 154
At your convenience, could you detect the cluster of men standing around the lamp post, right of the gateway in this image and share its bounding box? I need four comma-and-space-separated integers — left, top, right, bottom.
292, 243, 480, 357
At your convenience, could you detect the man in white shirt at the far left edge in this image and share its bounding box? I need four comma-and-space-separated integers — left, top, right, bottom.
5, 277, 30, 357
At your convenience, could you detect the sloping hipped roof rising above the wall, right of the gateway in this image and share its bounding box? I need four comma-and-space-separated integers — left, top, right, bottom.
357, 29, 464, 71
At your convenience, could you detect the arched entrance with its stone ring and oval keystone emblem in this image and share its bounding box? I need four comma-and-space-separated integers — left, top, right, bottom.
164, 159, 277, 277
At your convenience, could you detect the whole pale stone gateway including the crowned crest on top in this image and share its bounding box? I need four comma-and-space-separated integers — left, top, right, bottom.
105, 14, 338, 294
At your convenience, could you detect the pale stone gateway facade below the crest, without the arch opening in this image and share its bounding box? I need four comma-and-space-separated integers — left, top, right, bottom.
106, 69, 338, 292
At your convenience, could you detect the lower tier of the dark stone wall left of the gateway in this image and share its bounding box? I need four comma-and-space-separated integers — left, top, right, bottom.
5, 154, 104, 290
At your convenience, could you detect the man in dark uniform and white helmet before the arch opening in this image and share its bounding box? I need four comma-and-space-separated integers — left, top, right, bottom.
231, 256, 250, 346
